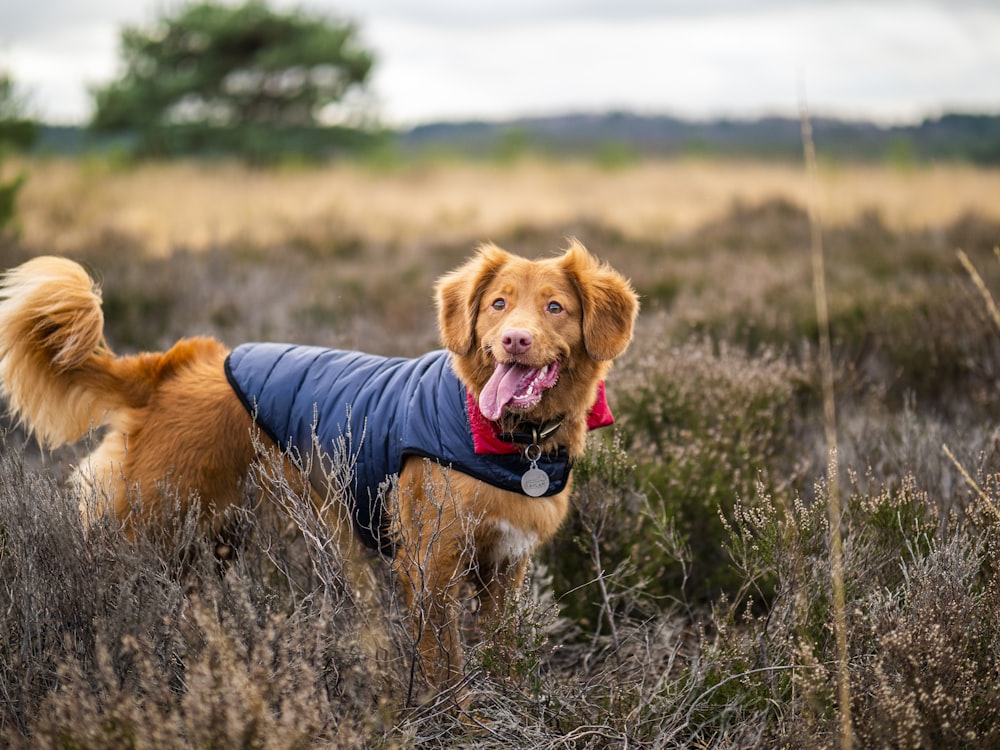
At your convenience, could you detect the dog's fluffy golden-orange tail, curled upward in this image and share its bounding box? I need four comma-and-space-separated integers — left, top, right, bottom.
0, 257, 138, 448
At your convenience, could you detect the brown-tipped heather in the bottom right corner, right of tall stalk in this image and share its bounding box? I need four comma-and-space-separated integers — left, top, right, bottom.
852, 522, 1000, 748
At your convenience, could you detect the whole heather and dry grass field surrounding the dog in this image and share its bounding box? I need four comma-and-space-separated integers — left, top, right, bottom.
0, 156, 1000, 748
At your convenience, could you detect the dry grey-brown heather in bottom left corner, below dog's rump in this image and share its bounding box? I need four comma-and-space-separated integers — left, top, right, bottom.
0, 449, 404, 748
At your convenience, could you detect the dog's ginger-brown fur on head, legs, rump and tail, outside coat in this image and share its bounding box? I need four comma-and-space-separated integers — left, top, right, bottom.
0, 242, 638, 704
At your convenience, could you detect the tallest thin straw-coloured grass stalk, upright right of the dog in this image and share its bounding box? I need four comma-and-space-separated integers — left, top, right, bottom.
801, 105, 854, 750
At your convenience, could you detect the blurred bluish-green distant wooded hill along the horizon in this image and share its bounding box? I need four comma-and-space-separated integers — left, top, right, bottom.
35, 112, 1000, 165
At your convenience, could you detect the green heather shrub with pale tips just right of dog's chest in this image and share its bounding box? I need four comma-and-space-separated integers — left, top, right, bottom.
615, 322, 798, 602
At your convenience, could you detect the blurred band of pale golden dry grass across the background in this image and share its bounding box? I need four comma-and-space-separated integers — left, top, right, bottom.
13, 159, 1000, 254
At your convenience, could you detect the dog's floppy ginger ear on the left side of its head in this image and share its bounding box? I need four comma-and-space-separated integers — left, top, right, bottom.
436, 244, 510, 356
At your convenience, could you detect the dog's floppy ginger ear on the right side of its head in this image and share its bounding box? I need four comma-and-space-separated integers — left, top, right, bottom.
559, 240, 639, 361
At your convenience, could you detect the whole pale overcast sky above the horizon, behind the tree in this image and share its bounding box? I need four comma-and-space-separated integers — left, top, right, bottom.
0, 0, 1000, 126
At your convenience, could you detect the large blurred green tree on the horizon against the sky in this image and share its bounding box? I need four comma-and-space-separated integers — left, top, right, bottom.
92, 0, 374, 156
